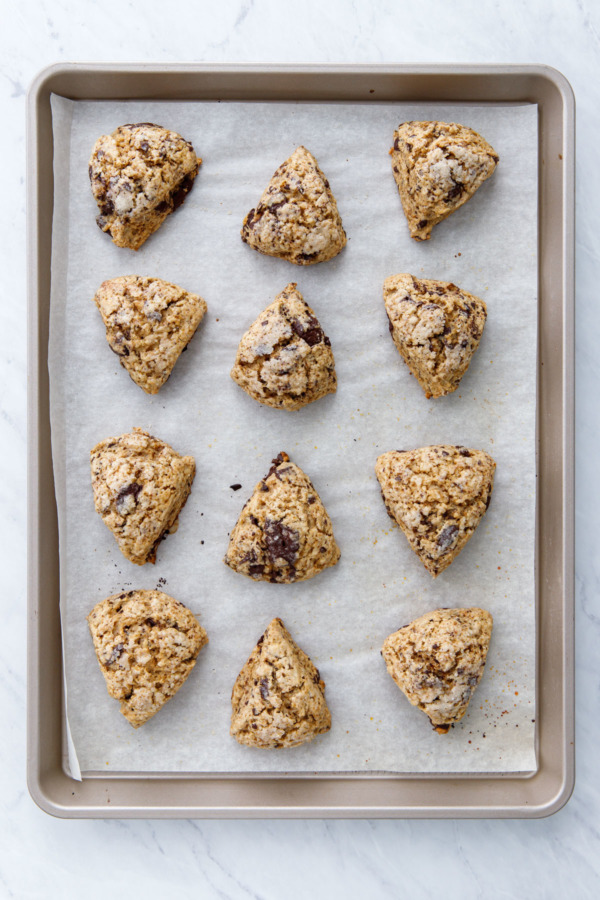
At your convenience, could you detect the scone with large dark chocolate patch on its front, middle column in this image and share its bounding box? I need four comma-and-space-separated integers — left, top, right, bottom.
224, 453, 340, 584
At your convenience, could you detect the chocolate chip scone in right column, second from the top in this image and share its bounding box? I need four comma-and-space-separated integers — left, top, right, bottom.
383, 275, 487, 398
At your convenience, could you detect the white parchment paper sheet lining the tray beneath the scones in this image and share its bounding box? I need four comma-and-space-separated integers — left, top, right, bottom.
50, 98, 537, 772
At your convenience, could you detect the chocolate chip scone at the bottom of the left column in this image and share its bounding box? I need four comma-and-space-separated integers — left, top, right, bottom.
87, 591, 208, 728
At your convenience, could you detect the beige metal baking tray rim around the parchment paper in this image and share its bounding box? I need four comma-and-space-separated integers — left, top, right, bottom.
27, 64, 575, 818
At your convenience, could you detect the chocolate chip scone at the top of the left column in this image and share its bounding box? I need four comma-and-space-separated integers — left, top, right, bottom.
88, 122, 202, 250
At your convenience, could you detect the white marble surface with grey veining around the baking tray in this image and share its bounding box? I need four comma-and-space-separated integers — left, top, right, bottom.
0, 0, 600, 900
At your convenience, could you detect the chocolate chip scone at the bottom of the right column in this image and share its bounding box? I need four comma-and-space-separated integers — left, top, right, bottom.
381, 608, 493, 734
